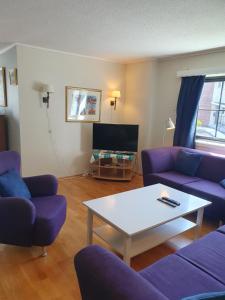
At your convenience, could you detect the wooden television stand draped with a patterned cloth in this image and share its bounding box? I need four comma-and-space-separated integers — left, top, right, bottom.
90, 150, 137, 181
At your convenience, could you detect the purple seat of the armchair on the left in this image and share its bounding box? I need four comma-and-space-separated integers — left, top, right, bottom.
31, 195, 66, 246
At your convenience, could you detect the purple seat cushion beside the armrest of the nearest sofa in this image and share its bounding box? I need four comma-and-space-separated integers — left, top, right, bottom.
140, 254, 225, 300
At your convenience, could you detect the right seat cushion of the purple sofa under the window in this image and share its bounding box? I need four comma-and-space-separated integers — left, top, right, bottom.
181, 179, 225, 220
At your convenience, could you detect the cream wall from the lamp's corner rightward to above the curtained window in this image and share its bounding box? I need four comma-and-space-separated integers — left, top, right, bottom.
124, 52, 225, 155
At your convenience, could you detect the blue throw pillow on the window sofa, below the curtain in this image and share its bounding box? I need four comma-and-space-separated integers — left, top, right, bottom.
174, 150, 202, 176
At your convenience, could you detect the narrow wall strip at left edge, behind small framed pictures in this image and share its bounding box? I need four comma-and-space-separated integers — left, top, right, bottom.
0, 47, 20, 152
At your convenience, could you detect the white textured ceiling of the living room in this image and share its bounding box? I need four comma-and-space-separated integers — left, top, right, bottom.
0, 0, 225, 61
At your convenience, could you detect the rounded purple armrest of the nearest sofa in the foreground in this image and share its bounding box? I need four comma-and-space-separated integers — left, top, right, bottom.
74, 245, 167, 300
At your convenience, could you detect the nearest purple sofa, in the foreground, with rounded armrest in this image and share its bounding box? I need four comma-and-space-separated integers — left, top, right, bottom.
75, 226, 225, 300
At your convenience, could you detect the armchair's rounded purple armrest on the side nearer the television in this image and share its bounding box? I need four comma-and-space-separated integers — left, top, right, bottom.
23, 175, 58, 197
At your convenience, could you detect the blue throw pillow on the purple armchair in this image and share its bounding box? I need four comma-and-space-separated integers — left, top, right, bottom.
0, 170, 31, 199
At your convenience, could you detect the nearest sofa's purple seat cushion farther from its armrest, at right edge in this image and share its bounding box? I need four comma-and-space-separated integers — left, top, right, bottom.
177, 232, 225, 284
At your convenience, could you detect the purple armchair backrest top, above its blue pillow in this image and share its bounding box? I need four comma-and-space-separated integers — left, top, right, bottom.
0, 151, 20, 174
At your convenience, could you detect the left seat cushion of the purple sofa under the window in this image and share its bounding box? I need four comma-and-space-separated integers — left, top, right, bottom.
146, 171, 200, 191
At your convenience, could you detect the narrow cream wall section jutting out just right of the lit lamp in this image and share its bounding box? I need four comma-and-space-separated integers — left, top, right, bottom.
124, 60, 158, 170
